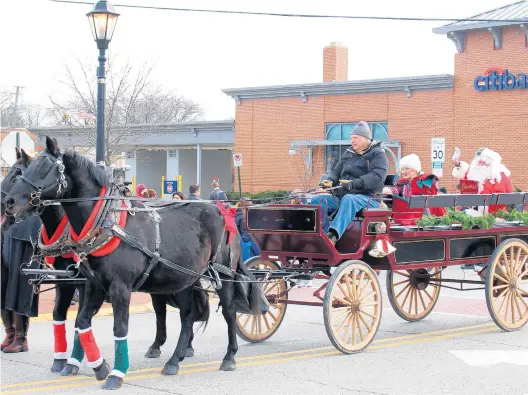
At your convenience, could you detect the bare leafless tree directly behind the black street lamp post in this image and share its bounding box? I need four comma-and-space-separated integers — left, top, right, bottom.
50, 58, 202, 164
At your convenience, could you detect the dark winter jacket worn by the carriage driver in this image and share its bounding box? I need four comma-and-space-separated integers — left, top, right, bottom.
328, 141, 389, 196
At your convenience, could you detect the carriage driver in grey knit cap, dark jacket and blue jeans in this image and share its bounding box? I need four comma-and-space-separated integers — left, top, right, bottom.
311, 121, 389, 245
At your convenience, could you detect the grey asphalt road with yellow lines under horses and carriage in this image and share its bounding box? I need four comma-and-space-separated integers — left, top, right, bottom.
1, 268, 528, 395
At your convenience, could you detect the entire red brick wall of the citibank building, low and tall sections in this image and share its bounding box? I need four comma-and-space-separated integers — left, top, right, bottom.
235, 24, 528, 192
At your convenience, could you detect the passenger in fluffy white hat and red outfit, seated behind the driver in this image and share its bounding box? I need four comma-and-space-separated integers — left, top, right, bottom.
383, 154, 446, 225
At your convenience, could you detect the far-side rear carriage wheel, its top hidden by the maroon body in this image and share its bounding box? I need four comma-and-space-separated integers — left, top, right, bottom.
387, 267, 442, 322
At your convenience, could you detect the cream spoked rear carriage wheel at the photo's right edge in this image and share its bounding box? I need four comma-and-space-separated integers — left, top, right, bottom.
486, 239, 528, 332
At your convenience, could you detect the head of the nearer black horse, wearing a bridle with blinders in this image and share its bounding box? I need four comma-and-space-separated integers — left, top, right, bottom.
2, 137, 68, 219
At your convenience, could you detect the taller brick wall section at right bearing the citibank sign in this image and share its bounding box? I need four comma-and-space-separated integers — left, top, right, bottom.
454, 27, 528, 189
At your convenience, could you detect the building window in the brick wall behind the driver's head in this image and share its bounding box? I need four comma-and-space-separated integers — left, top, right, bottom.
325, 122, 389, 173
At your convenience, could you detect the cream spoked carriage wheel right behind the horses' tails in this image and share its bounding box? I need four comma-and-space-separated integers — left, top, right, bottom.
236, 257, 288, 343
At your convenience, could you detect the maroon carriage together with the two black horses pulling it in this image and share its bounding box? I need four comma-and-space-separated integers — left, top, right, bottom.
3, 142, 528, 389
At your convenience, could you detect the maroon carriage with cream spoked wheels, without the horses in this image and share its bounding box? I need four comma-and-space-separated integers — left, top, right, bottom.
237, 184, 528, 353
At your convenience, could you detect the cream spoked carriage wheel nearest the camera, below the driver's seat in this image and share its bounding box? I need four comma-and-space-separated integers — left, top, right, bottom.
323, 261, 382, 354
